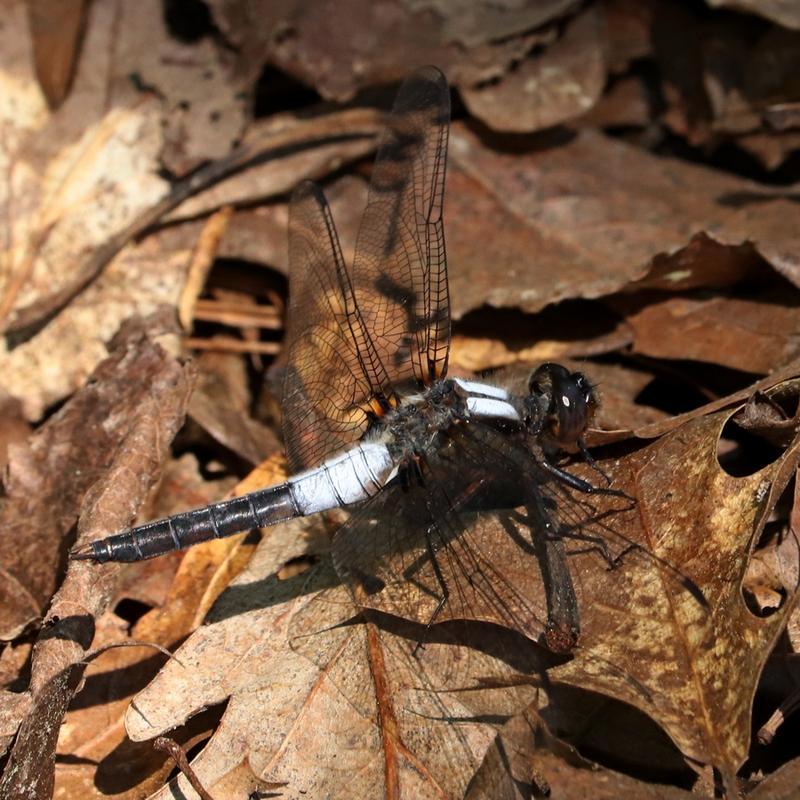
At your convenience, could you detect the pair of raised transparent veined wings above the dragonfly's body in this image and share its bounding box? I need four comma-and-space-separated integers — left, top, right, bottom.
283, 67, 450, 471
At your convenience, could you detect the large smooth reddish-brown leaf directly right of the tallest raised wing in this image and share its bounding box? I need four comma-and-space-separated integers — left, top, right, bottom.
446, 124, 800, 318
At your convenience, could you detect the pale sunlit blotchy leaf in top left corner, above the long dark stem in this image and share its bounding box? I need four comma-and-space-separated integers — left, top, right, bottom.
0, 2, 167, 332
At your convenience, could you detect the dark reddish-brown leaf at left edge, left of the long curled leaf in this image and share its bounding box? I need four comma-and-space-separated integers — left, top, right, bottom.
0, 315, 184, 639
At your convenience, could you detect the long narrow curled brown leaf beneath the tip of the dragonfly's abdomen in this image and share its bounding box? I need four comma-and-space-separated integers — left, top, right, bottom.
0, 310, 192, 800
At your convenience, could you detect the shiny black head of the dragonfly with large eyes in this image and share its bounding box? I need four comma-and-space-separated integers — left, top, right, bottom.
528, 363, 597, 450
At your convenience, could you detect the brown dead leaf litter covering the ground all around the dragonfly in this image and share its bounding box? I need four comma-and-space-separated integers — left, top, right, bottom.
0, 0, 800, 799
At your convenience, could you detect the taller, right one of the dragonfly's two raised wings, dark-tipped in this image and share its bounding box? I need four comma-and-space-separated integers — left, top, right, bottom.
353, 67, 450, 385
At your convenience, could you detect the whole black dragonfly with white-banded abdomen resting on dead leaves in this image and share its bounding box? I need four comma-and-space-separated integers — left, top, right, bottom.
71, 67, 626, 652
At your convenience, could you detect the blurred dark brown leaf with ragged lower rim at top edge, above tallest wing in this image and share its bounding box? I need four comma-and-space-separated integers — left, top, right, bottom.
208, 0, 574, 101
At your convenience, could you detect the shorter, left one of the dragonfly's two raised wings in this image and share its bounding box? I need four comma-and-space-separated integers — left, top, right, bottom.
283, 182, 388, 472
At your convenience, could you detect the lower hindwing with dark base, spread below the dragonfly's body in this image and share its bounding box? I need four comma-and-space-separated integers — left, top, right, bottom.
333, 424, 560, 639
